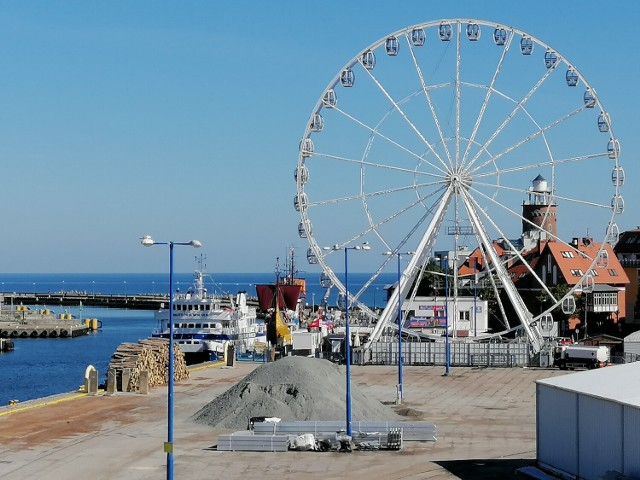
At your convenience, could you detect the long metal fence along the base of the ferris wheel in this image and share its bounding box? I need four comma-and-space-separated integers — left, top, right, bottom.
352, 341, 532, 367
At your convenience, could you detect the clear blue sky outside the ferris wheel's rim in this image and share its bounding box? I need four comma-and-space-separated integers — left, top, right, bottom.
0, 0, 640, 272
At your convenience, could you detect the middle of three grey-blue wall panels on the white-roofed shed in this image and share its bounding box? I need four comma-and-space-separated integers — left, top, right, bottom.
578, 395, 623, 480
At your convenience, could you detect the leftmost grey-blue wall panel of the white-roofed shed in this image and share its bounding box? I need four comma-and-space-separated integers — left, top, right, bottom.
536, 384, 578, 475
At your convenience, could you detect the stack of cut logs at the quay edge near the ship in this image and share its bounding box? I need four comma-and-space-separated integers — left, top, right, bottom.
109, 338, 189, 391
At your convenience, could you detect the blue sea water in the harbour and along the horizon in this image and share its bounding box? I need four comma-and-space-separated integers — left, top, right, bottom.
0, 273, 396, 405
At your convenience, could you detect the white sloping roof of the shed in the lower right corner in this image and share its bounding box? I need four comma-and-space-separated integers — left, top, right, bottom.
536, 362, 640, 407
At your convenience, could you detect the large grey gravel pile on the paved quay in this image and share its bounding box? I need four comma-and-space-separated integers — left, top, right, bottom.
193, 357, 400, 429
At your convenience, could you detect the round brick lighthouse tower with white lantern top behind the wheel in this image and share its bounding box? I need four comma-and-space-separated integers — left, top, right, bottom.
522, 175, 558, 249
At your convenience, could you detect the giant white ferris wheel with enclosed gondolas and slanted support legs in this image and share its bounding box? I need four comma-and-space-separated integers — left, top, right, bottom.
294, 19, 624, 351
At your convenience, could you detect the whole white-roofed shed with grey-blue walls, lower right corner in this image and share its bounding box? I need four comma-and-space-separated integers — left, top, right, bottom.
536, 374, 640, 480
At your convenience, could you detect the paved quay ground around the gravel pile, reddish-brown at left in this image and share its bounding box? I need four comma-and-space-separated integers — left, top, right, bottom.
0, 362, 565, 480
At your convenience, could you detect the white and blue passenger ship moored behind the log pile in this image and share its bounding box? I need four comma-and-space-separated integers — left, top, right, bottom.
152, 270, 266, 363
